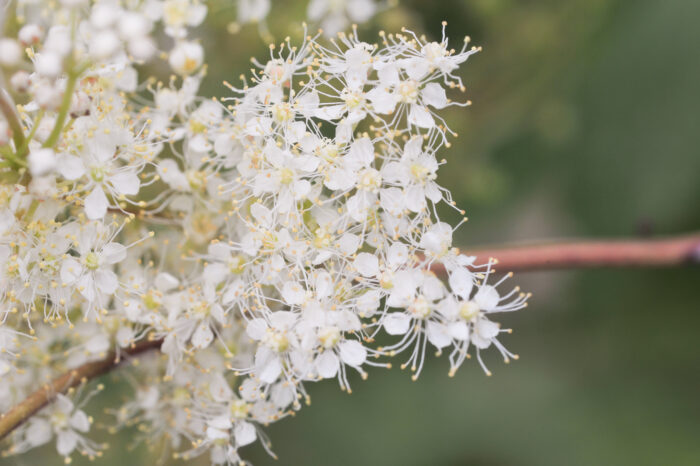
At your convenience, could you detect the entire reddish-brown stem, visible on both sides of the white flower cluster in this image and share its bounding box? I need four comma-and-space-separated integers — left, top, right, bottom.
0, 233, 700, 440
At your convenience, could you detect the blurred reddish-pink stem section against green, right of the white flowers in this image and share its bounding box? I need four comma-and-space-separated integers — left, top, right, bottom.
452, 233, 700, 272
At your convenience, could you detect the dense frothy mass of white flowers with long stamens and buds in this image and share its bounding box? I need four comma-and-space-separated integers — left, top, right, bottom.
0, 0, 527, 464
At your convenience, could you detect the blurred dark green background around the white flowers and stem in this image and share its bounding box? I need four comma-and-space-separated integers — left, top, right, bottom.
2, 0, 700, 466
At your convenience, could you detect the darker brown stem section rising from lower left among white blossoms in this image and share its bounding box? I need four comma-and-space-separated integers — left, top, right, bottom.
0, 340, 163, 440
